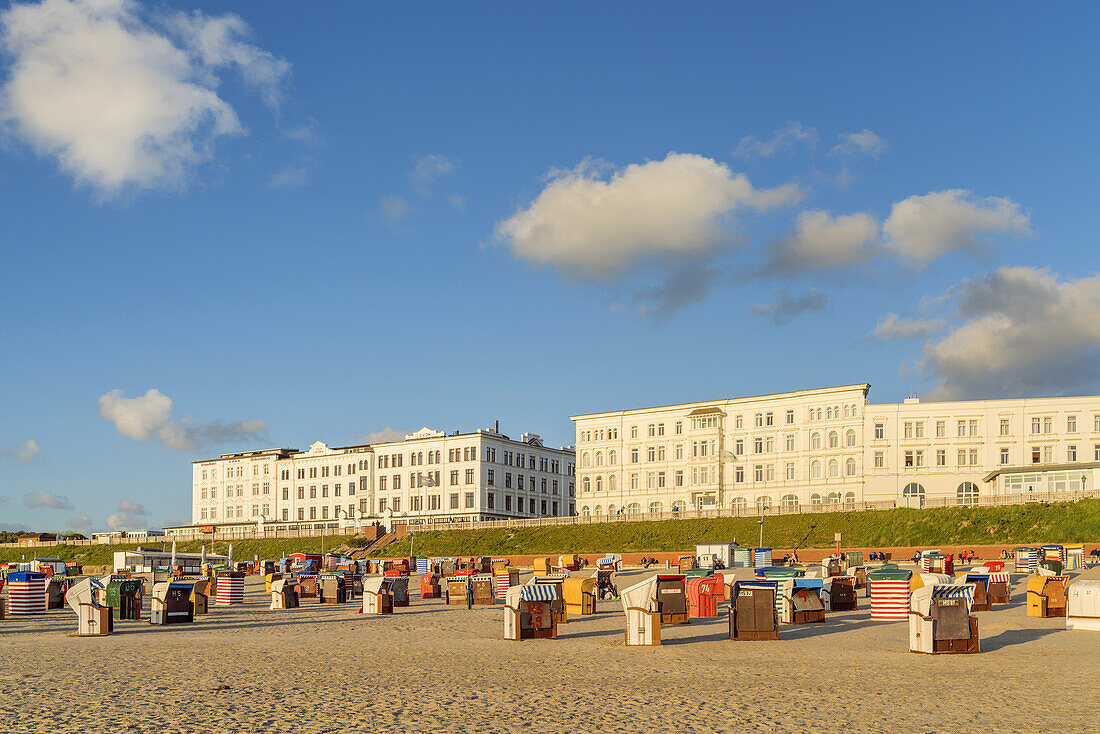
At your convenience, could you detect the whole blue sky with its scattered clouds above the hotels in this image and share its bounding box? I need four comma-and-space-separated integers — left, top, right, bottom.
0, 0, 1100, 530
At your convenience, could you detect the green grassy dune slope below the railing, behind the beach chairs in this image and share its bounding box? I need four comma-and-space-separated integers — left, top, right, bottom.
0, 500, 1100, 566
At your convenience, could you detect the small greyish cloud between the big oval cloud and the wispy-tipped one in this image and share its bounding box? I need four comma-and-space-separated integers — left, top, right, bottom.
765, 210, 880, 275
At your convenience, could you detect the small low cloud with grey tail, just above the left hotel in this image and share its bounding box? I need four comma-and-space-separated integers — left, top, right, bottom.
99, 388, 267, 451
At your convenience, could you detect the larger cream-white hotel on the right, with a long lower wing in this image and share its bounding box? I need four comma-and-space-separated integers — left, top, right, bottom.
573, 384, 1100, 517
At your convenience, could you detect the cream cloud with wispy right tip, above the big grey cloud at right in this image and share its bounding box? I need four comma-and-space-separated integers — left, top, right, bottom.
882, 188, 1031, 265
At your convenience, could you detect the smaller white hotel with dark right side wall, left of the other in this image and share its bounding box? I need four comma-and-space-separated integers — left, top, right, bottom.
191, 427, 575, 529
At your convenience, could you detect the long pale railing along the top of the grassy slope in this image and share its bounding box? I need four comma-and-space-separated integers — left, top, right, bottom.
8, 490, 1100, 548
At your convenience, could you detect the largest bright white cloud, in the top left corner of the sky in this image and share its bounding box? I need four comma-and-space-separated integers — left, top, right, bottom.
0, 0, 289, 196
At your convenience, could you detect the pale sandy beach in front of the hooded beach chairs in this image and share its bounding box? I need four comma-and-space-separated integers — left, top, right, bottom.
0, 569, 1100, 734
